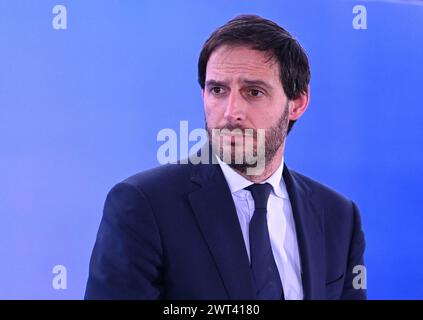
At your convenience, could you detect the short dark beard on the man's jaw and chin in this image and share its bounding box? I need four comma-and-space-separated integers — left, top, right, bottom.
206, 102, 289, 175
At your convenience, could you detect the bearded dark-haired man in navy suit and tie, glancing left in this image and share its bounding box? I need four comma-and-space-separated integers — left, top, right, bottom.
85, 15, 366, 299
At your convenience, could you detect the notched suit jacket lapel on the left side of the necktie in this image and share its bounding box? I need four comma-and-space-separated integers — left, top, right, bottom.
188, 164, 255, 299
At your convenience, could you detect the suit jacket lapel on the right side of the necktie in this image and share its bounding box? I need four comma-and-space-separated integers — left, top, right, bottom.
283, 166, 326, 299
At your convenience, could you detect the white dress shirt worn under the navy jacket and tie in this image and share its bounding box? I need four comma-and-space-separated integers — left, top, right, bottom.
216, 157, 303, 300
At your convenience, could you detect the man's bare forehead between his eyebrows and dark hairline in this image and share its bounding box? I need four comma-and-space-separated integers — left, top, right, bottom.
206, 45, 279, 81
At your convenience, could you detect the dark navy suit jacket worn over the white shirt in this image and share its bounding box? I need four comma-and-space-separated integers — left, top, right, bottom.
85, 158, 366, 300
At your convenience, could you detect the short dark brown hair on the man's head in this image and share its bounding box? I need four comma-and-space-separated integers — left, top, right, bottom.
198, 15, 310, 132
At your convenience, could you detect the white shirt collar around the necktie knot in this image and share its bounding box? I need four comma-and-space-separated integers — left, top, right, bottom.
216, 157, 289, 199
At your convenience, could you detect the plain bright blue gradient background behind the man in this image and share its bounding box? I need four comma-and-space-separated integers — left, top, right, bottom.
0, 0, 423, 299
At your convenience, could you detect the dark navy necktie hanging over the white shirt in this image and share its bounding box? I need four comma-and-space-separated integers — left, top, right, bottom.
245, 183, 284, 300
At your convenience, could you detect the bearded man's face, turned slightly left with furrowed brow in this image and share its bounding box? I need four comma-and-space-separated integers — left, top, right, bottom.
203, 46, 289, 173
